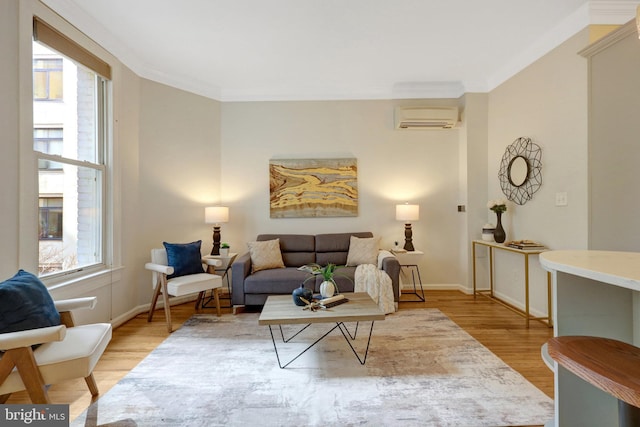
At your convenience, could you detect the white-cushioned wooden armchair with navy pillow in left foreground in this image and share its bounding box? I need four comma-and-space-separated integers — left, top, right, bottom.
0, 270, 111, 404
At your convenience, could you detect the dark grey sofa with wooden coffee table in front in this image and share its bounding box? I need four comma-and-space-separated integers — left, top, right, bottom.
231, 232, 400, 306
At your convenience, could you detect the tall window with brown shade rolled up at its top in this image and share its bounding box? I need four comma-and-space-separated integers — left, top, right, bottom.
33, 18, 110, 276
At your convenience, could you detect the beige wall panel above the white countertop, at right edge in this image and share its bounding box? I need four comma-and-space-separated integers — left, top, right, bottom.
589, 22, 640, 251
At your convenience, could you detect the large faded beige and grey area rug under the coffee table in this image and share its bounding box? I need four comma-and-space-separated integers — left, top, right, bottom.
72, 309, 553, 427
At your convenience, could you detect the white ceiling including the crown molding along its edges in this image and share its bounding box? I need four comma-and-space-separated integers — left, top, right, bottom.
43, 0, 638, 101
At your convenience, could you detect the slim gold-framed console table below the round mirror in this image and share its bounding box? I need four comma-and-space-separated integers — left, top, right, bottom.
471, 240, 553, 328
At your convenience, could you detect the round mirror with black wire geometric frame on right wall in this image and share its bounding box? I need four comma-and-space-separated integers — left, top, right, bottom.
498, 137, 542, 205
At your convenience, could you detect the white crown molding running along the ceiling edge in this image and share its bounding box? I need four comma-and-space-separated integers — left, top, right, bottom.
41, 0, 638, 101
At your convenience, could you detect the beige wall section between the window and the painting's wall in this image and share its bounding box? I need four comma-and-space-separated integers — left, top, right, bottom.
135, 79, 221, 303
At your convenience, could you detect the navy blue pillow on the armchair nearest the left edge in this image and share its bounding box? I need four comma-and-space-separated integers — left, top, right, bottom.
0, 270, 60, 333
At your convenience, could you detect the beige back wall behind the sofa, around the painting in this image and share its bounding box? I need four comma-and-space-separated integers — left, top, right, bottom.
221, 100, 461, 284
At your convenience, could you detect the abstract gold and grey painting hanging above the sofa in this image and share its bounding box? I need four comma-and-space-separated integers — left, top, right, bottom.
269, 158, 358, 218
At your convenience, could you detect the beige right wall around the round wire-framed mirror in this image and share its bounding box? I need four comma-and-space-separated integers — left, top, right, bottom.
487, 30, 588, 311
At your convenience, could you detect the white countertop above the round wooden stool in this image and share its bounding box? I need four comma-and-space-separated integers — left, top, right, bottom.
540, 250, 640, 291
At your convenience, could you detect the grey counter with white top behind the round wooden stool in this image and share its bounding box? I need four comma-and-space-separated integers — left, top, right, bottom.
540, 251, 640, 427
